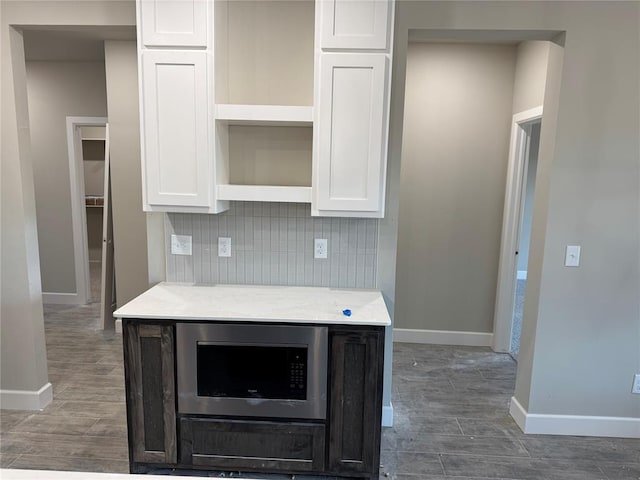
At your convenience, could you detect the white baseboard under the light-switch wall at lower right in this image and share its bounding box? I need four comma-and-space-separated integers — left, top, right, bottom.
509, 397, 640, 438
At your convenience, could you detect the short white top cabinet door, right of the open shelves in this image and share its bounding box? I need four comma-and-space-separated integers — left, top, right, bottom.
318, 0, 393, 50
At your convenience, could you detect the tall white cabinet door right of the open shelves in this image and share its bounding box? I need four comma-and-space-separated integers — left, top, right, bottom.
313, 53, 388, 214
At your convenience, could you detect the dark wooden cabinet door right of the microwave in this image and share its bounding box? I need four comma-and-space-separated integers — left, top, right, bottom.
329, 327, 384, 477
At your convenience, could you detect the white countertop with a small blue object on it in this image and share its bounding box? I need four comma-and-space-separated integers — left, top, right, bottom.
114, 282, 391, 326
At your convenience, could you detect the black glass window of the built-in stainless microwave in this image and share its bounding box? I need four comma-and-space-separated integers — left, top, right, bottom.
197, 343, 307, 400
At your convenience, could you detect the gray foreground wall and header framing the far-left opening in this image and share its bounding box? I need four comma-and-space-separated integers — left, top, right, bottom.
0, 1, 135, 404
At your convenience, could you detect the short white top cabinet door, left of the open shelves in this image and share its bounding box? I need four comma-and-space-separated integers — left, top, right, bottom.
138, 0, 208, 47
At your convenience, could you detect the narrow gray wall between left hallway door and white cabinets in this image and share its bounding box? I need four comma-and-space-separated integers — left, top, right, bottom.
104, 41, 163, 306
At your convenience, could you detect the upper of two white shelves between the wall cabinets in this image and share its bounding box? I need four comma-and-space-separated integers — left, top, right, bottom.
215, 104, 313, 127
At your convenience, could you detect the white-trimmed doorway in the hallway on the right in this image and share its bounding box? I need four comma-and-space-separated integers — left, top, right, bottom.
493, 106, 542, 352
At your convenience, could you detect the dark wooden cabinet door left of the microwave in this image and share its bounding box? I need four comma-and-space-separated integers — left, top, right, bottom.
123, 320, 178, 465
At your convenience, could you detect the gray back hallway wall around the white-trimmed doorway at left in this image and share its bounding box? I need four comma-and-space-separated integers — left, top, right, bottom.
26, 61, 107, 293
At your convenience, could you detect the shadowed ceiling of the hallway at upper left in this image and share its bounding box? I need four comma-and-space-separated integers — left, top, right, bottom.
23, 26, 136, 62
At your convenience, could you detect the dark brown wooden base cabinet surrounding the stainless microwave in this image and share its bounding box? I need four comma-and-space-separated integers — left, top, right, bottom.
123, 319, 384, 478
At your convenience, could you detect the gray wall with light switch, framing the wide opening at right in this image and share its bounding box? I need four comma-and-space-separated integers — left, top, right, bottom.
378, 1, 640, 418
